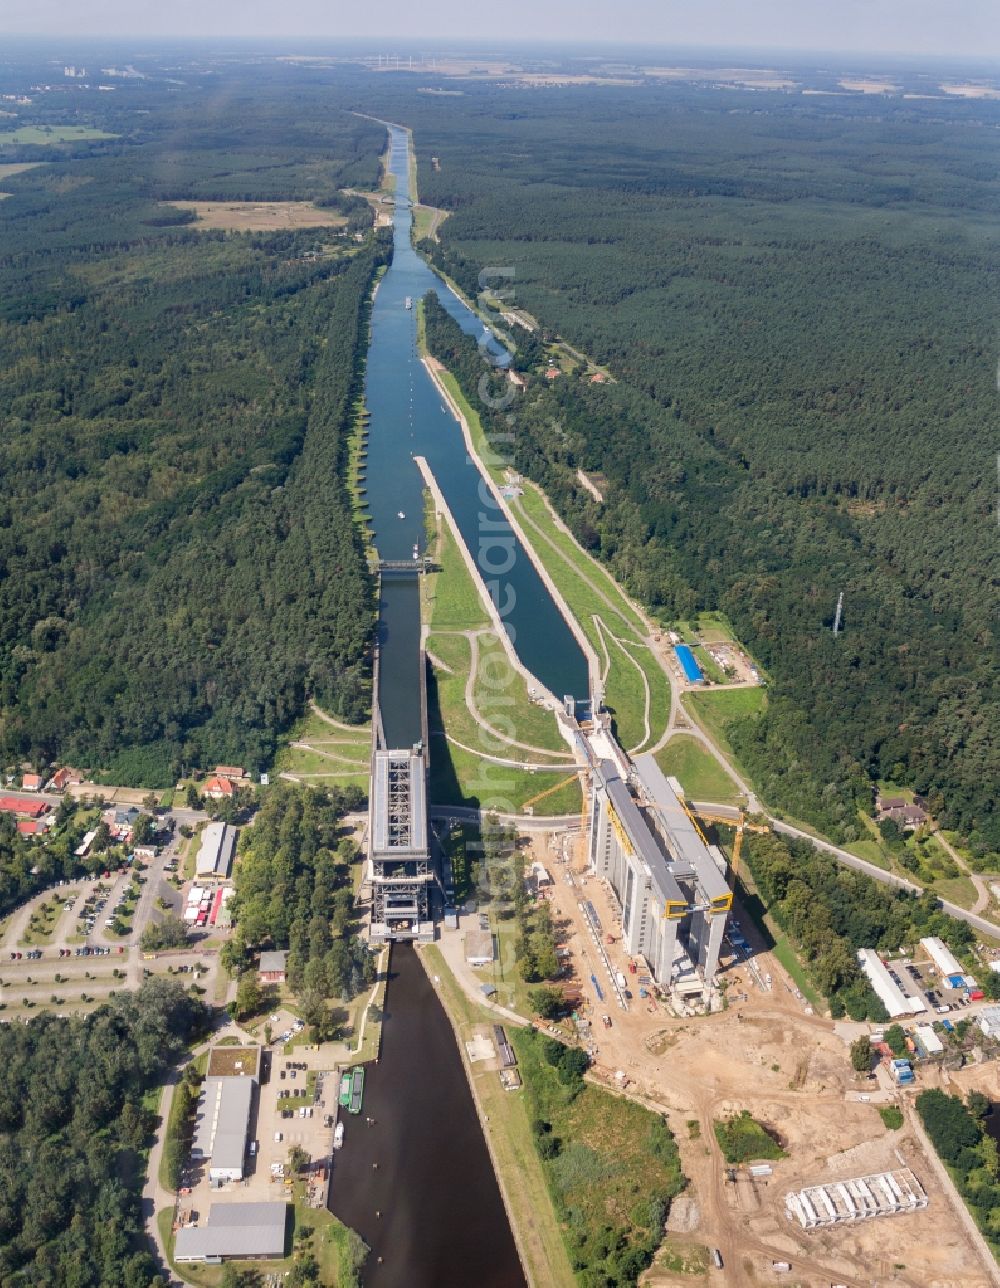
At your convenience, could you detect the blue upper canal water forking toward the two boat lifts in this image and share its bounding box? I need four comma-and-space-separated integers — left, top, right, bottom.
365, 126, 588, 747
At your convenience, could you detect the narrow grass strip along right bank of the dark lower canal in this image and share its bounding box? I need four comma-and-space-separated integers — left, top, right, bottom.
420, 945, 576, 1288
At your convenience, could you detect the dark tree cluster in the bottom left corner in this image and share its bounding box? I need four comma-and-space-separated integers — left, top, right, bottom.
0, 979, 204, 1288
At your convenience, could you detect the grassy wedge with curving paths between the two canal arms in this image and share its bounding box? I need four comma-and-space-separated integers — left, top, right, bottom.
424, 507, 581, 814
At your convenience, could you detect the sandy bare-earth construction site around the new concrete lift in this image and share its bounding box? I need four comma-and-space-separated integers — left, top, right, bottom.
512, 833, 1000, 1288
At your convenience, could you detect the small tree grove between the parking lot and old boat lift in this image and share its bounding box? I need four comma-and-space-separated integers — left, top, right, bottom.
223, 784, 375, 1038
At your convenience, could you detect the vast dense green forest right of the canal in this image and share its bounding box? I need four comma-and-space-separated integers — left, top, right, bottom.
404, 85, 1000, 862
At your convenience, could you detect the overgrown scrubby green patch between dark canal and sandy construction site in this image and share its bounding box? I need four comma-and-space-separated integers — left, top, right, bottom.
510, 1029, 684, 1283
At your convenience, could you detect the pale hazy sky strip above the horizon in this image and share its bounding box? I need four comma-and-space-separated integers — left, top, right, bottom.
0, 0, 1000, 59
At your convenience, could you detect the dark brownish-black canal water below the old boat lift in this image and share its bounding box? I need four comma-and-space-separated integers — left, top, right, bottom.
330, 944, 524, 1288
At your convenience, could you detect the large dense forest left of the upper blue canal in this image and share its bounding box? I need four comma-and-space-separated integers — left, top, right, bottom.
0, 68, 389, 786
